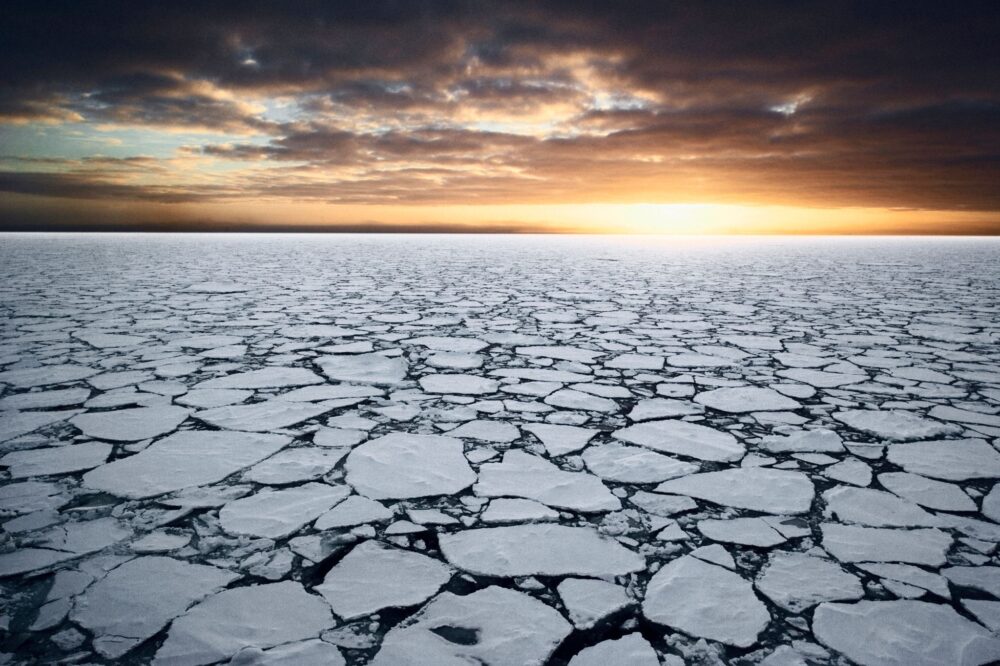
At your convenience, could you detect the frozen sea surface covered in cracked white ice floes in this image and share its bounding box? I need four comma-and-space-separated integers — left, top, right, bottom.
0, 234, 1000, 666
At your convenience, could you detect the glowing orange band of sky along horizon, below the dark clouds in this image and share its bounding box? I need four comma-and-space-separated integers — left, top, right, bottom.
0, 195, 1000, 235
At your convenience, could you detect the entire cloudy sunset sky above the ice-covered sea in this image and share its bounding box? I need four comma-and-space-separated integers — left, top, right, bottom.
0, 0, 1000, 235
